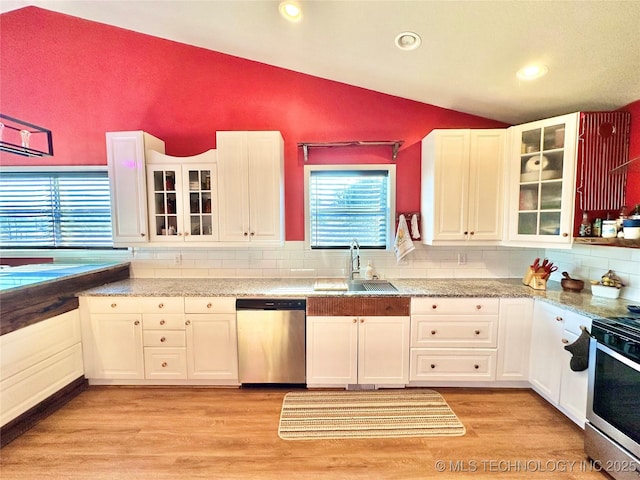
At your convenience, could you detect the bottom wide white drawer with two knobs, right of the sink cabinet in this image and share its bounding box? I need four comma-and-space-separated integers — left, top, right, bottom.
409, 348, 496, 381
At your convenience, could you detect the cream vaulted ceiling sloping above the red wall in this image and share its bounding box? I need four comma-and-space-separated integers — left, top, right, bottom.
0, 0, 640, 124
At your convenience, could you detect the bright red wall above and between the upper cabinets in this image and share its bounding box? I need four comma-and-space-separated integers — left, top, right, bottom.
0, 7, 640, 240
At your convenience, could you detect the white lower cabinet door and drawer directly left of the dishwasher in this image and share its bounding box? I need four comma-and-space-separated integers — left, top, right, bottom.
185, 297, 238, 385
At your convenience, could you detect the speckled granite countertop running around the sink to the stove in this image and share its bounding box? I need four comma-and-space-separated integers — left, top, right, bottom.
78, 278, 631, 318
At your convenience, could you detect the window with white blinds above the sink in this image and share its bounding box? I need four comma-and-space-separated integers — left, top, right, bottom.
305, 165, 395, 249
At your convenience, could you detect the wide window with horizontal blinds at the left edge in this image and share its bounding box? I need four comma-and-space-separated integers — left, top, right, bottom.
0, 170, 113, 248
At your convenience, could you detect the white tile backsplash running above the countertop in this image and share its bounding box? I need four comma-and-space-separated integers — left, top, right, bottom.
3, 242, 640, 301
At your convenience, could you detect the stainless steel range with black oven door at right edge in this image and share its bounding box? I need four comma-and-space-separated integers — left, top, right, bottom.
585, 316, 640, 480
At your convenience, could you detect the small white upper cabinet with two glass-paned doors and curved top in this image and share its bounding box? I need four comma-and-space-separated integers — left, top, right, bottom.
147, 150, 218, 243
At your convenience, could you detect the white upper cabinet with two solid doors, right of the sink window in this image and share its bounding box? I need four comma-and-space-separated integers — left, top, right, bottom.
421, 129, 506, 245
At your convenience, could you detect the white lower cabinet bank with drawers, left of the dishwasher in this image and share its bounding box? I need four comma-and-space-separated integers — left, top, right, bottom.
80, 297, 238, 385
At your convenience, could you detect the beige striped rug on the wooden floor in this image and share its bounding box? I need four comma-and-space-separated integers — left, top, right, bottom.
278, 389, 465, 440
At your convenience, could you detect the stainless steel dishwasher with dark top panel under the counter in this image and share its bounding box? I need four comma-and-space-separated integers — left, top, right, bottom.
236, 299, 307, 385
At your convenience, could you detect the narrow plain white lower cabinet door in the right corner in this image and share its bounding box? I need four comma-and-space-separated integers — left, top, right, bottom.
496, 298, 533, 382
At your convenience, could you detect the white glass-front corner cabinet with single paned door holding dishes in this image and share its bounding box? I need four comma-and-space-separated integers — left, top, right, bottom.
507, 113, 579, 246
